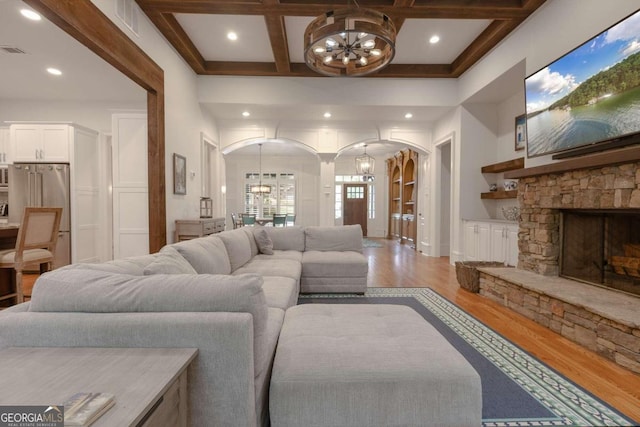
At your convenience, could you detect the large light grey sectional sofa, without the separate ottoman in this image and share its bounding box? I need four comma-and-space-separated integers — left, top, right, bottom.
0, 226, 368, 427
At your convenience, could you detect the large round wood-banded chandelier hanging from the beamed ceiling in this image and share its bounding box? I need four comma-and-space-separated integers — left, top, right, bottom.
304, 7, 396, 76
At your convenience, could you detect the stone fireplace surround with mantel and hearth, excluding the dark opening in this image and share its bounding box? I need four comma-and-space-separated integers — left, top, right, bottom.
480, 147, 640, 374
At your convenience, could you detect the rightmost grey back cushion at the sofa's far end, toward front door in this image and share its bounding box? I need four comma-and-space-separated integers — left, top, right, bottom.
304, 224, 362, 253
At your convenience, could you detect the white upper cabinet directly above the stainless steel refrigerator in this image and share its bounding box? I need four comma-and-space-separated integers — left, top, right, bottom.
9, 123, 73, 163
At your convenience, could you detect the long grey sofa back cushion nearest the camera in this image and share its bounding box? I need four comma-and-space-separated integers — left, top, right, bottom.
29, 269, 271, 375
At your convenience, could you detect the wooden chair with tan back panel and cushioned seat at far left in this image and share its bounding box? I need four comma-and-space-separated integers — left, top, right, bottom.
0, 207, 62, 304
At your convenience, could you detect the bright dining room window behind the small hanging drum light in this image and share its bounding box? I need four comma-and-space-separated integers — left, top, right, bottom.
244, 172, 296, 218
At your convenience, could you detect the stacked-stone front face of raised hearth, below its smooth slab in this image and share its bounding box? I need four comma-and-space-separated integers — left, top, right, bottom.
480, 272, 640, 374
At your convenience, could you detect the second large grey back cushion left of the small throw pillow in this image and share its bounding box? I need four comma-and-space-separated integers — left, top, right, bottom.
171, 236, 231, 274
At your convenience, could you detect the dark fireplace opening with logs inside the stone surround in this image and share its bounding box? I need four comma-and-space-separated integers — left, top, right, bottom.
560, 210, 640, 295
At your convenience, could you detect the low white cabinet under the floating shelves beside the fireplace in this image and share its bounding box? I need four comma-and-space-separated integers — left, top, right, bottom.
464, 221, 518, 266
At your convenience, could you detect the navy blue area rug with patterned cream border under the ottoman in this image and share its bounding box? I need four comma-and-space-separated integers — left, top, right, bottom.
298, 288, 638, 427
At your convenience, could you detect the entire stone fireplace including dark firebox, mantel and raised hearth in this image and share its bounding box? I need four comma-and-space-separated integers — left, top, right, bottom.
480, 154, 640, 374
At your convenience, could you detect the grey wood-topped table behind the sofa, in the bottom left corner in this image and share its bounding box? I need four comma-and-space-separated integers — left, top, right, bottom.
0, 347, 198, 427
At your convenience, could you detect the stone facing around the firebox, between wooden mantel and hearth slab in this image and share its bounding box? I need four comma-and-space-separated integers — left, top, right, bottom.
518, 162, 640, 276
